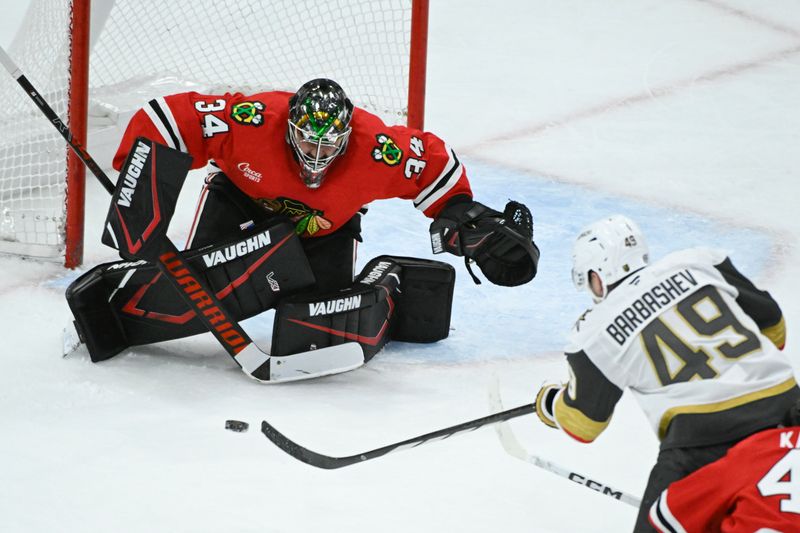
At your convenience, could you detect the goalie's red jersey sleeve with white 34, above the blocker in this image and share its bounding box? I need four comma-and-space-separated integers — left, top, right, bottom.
113, 92, 236, 170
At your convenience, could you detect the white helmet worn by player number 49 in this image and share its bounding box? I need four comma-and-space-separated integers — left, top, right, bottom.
572, 215, 649, 302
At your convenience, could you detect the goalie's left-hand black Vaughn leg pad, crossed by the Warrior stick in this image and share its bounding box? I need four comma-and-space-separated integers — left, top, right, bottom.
66, 217, 314, 361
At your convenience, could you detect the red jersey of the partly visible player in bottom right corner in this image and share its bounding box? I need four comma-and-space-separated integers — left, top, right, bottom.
650, 427, 800, 533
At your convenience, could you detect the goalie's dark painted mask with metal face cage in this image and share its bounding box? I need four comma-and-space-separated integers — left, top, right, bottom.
286, 78, 353, 189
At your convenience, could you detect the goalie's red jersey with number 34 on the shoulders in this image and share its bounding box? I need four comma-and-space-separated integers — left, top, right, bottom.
114, 92, 472, 237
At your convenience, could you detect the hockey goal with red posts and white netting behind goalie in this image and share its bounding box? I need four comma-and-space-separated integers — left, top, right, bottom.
0, 0, 427, 266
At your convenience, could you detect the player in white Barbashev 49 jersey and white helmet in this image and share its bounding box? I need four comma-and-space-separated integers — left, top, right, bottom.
536, 215, 800, 532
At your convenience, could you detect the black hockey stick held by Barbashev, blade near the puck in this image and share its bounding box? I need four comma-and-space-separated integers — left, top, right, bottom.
261, 404, 534, 470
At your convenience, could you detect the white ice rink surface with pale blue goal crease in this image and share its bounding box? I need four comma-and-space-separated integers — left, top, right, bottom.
0, 0, 800, 532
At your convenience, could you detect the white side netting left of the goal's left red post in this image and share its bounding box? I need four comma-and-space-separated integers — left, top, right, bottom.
0, 2, 70, 257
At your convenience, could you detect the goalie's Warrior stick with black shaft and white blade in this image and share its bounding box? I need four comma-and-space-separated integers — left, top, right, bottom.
0, 47, 364, 382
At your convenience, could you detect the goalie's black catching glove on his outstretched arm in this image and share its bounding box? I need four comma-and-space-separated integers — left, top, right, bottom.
430, 200, 539, 287
